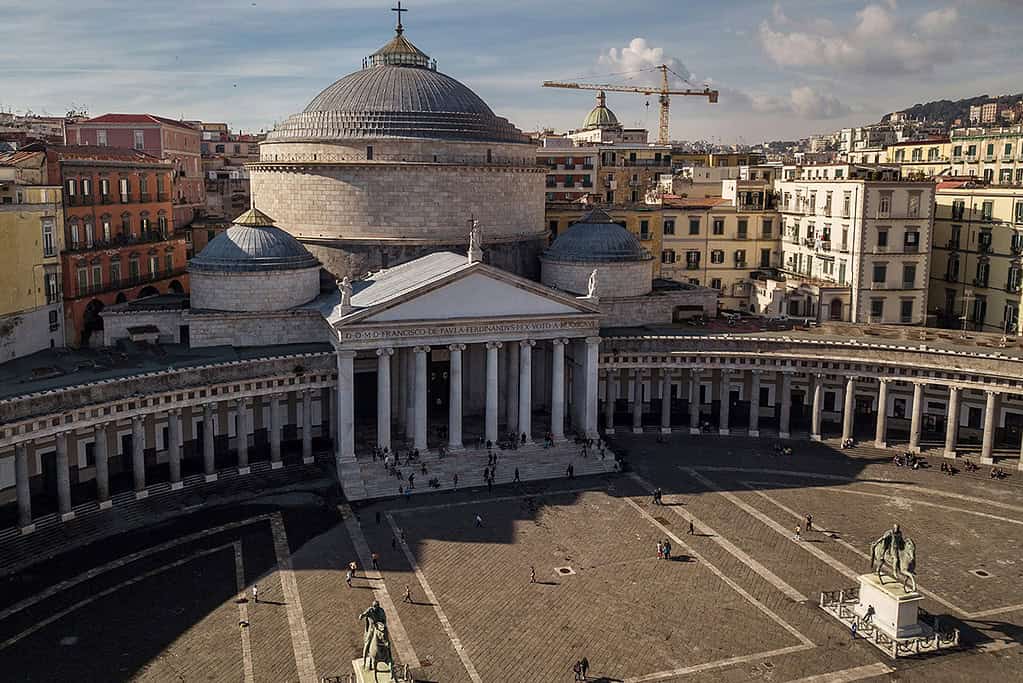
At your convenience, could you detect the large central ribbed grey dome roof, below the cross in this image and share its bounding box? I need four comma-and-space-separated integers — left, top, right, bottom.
267, 32, 528, 143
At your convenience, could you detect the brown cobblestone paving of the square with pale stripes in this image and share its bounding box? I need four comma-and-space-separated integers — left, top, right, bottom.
0, 436, 1023, 683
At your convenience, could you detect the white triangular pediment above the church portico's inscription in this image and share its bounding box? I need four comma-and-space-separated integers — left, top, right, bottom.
362, 271, 583, 322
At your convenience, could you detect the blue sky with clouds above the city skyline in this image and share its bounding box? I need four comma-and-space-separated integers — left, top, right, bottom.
0, 0, 1023, 144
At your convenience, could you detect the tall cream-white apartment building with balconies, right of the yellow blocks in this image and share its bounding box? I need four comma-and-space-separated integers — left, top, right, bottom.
773, 165, 934, 325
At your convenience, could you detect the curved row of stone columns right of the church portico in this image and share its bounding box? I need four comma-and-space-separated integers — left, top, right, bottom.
604, 367, 1023, 468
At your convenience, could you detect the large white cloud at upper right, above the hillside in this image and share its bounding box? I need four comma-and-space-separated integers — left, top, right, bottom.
760, 1, 959, 74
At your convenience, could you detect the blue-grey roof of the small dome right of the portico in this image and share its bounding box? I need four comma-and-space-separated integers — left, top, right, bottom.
543, 209, 654, 263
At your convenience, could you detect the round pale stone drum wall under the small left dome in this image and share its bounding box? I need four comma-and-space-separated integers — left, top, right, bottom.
191, 267, 319, 312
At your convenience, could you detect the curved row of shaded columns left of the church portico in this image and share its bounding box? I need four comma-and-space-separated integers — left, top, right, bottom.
7, 389, 322, 531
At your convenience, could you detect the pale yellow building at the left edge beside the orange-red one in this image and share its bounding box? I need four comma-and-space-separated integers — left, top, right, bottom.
0, 152, 63, 362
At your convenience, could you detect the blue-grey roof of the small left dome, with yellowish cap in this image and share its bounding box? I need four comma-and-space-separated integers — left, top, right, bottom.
188, 209, 320, 272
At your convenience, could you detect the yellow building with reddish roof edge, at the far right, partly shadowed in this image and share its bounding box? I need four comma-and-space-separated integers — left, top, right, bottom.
928, 181, 1023, 334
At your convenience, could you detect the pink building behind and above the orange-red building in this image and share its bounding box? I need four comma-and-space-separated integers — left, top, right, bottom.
68, 113, 206, 230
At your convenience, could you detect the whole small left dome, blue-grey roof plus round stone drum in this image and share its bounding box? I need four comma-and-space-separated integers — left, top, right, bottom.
188, 209, 320, 313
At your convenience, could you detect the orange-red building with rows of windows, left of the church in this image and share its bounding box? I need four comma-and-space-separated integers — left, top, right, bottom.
32, 145, 188, 347
